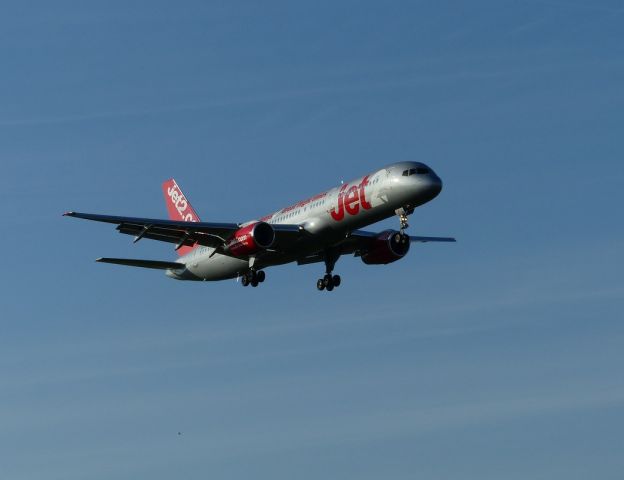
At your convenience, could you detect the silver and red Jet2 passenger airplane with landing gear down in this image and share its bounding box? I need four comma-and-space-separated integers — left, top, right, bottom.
64, 162, 455, 292
